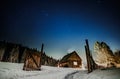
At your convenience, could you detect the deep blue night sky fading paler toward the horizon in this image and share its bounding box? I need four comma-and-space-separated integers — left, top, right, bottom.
0, 0, 120, 58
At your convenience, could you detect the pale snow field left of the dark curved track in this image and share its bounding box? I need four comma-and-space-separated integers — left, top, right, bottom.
0, 62, 80, 79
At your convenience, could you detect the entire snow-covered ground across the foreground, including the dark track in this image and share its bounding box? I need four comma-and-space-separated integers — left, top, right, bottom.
0, 62, 120, 79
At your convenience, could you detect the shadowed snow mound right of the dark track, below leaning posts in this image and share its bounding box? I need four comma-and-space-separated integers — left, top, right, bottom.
72, 68, 120, 79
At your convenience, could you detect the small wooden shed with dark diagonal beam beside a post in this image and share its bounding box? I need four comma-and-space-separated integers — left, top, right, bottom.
23, 51, 41, 71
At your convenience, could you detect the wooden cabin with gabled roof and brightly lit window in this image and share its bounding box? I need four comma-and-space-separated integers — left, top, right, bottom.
58, 51, 82, 68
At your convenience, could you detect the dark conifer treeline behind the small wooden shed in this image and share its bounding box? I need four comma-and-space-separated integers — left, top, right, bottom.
0, 41, 57, 66
